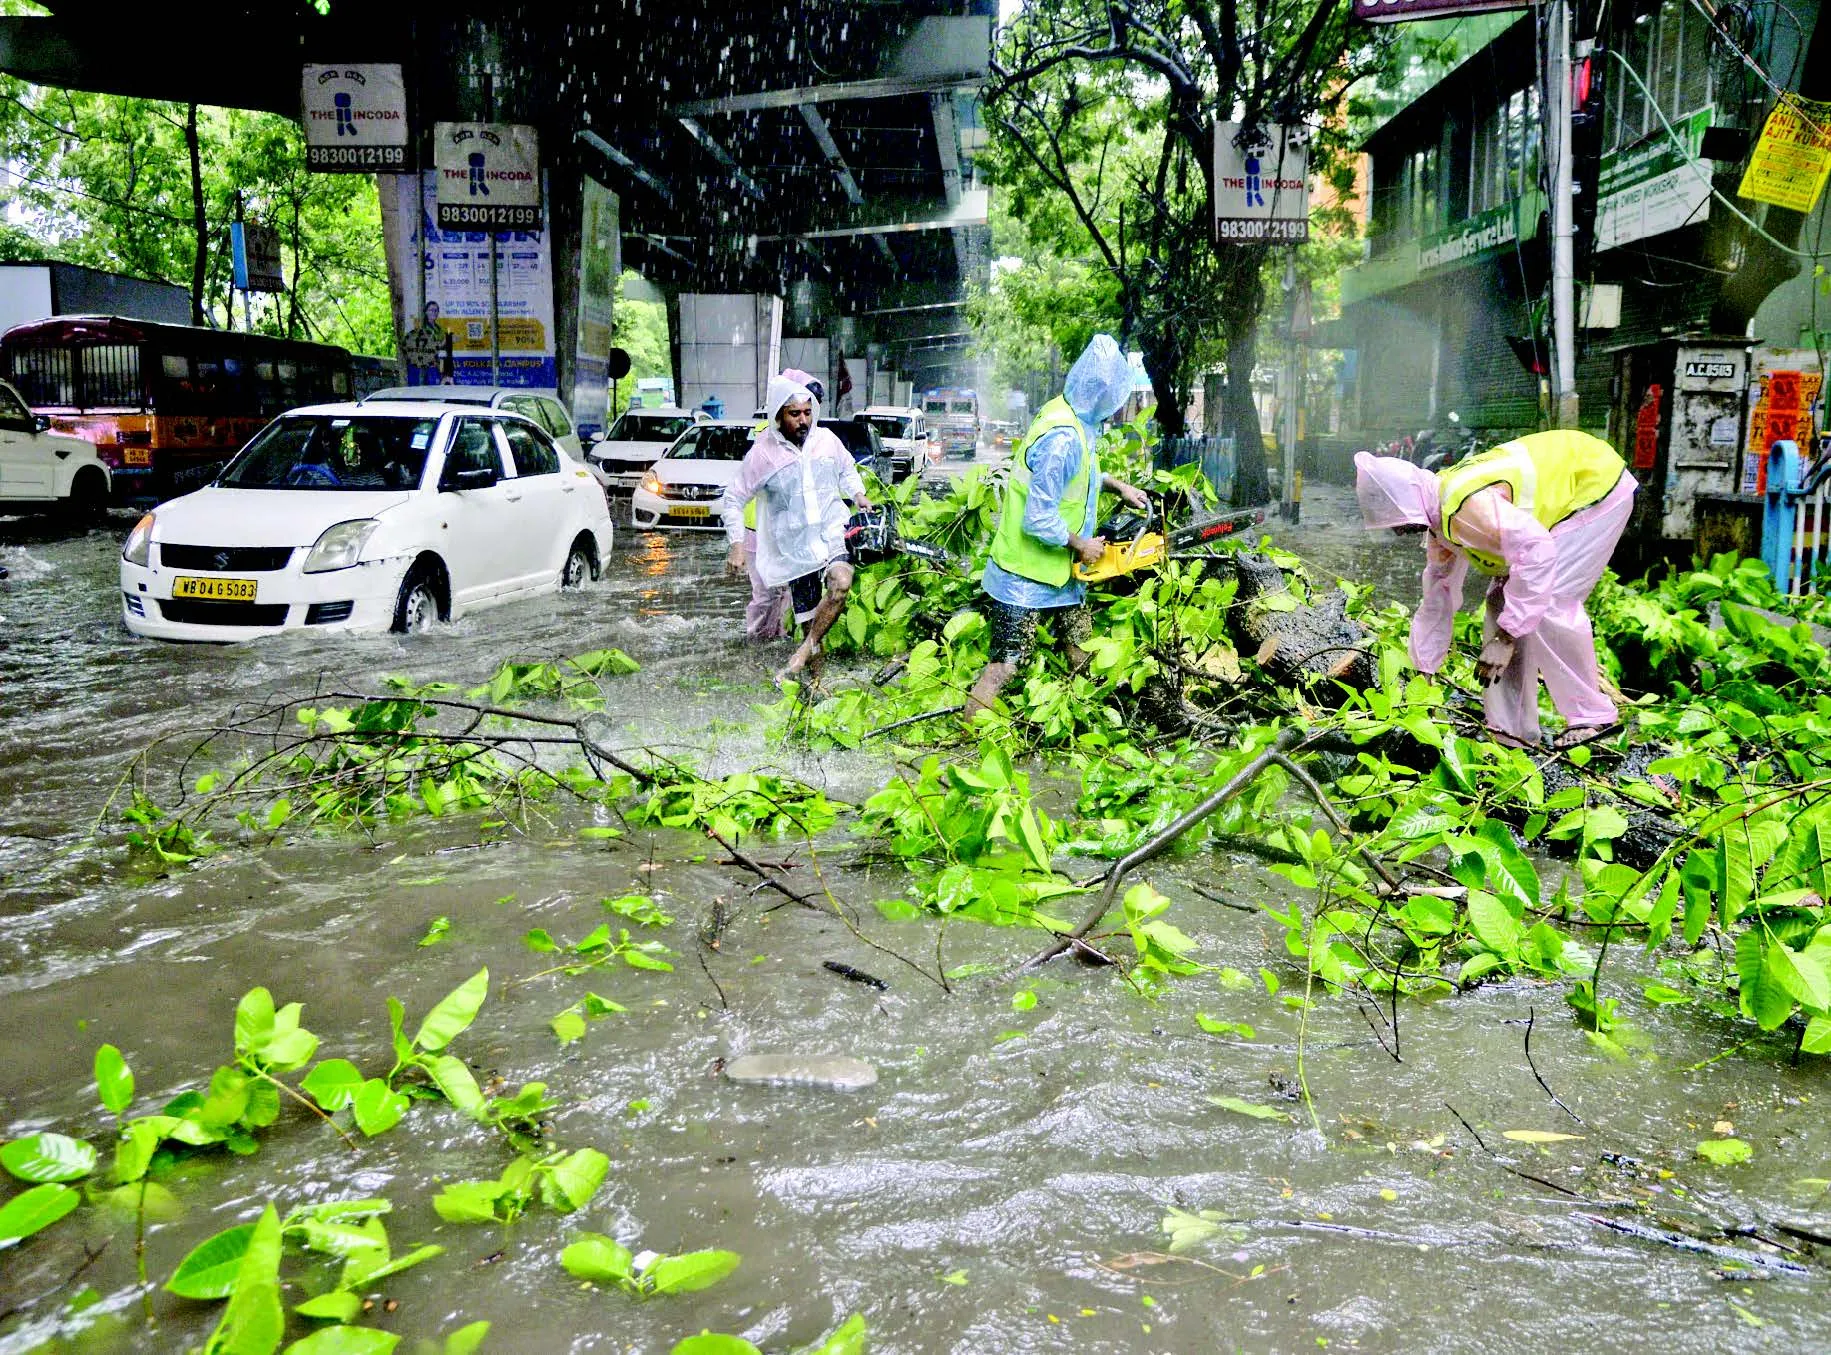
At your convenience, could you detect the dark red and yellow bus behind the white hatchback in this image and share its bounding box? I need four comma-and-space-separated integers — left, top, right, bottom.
0, 315, 352, 500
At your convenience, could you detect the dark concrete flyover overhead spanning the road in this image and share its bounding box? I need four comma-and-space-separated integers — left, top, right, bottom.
0, 0, 994, 411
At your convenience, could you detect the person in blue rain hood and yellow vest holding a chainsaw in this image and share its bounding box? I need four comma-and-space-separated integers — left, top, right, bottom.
965, 333, 1148, 720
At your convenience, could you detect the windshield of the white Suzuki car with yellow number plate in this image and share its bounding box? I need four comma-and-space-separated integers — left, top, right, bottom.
218, 414, 439, 489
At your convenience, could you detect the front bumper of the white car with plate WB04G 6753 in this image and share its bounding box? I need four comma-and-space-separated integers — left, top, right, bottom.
121, 551, 408, 643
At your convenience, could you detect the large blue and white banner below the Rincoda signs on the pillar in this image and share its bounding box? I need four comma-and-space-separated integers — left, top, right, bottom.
383, 174, 557, 386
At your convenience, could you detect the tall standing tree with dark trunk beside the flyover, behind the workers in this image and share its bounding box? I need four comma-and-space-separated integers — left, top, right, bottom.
983, 0, 1381, 502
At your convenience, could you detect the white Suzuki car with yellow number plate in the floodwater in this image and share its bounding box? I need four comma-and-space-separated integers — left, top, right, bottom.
121, 401, 613, 641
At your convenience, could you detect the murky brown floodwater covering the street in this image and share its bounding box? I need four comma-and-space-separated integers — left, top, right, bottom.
0, 489, 1831, 1355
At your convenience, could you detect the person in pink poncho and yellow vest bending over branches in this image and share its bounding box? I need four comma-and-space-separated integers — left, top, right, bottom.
1355, 428, 1635, 747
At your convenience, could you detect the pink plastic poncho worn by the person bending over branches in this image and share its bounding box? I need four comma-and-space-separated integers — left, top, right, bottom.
1355, 452, 1635, 743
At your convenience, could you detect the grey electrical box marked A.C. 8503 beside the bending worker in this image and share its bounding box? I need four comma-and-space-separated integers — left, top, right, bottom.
1609, 335, 1754, 558
